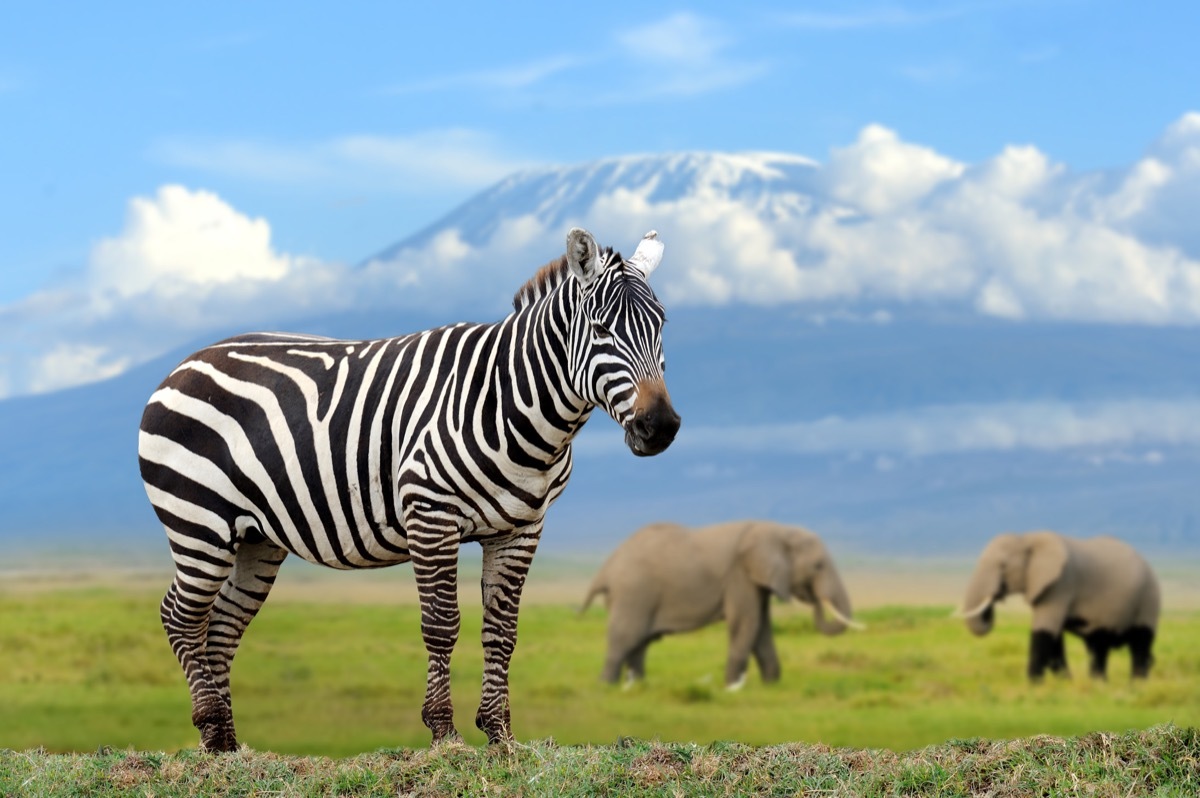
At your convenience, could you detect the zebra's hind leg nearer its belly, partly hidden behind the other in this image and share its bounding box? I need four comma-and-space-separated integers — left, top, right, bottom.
208, 540, 288, 720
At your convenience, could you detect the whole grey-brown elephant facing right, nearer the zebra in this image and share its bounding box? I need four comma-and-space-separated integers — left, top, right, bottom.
580, 521, 862, 690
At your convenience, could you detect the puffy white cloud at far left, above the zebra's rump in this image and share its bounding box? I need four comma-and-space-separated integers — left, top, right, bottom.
0, 186, 353, 395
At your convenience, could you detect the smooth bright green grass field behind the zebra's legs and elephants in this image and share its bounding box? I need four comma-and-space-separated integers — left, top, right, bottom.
0, 588, 1200, 757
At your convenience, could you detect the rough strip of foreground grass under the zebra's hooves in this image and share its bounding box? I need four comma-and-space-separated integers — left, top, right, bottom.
0, 726, 1200, 798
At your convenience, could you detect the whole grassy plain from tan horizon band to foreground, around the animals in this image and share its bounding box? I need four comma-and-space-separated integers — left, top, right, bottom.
0, 557, 1200, 794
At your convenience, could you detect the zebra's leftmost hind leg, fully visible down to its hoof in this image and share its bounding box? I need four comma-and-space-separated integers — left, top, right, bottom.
160, 535, 238, 751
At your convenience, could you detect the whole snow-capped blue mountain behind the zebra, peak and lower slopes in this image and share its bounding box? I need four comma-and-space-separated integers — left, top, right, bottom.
0, 154, 1200, 556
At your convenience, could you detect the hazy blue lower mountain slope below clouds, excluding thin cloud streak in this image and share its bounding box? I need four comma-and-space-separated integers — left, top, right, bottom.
0, 311, 1200, 552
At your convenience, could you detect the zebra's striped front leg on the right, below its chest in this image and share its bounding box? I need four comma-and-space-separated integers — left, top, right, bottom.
475, 523, 541, 743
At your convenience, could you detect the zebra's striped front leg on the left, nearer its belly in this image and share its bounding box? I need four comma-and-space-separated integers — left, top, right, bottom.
404, 517, 460, 743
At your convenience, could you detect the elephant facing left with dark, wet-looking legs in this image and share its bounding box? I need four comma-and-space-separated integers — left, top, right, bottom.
955, 530, 1162, 682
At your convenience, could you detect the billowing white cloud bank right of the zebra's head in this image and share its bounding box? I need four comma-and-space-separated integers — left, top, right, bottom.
589, 114, 1200, 324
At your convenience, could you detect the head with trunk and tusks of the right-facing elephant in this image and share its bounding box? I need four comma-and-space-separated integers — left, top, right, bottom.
738, 523, 863, 635
